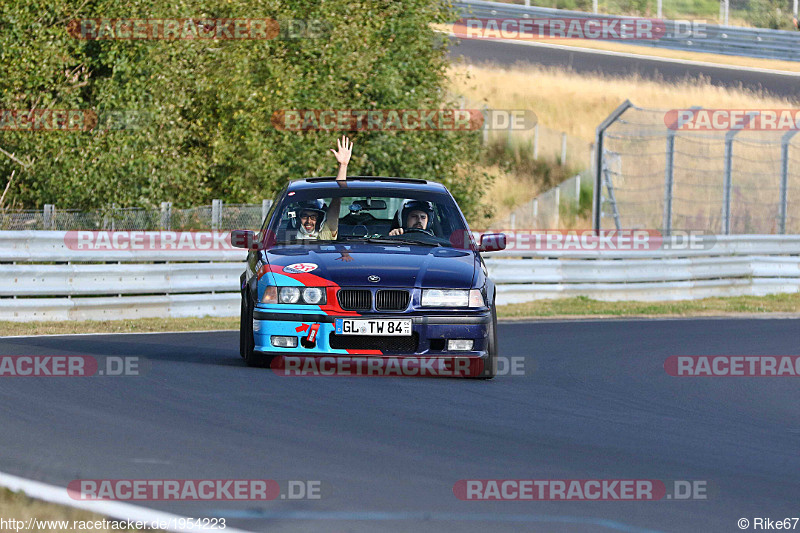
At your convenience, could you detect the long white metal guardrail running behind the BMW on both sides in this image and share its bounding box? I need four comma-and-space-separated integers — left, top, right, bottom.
0, 231, 800, 320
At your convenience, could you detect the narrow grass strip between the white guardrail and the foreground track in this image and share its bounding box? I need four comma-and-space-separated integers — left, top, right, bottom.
0, 293, 800, 335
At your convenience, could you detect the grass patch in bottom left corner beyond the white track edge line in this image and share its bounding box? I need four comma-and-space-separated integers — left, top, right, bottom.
0, 489, 156, 533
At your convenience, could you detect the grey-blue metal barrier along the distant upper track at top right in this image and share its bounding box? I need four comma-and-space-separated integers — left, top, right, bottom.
453, 0, 800, 61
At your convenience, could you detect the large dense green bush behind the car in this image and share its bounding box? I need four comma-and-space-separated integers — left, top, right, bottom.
0, 0, 482, 219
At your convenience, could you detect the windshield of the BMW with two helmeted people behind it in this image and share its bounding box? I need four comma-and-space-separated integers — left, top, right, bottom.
262, 189, 470, 248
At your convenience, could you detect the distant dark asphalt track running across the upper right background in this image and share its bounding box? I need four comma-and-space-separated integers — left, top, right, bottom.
450, 37, 800, 103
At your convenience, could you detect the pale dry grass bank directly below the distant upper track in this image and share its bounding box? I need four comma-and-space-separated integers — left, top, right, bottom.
449, 65, 798, 143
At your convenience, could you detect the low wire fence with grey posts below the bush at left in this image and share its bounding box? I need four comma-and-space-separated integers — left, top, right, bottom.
0, 200, 272, 231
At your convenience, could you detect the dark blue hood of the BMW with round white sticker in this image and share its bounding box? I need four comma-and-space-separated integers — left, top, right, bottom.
262, 243, 477, 289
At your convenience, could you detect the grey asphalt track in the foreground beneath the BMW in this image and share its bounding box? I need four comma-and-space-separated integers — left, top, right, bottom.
0, 319, 800, 533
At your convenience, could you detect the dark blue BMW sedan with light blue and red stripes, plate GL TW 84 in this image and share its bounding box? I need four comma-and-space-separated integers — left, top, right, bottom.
232, 177, 505, 378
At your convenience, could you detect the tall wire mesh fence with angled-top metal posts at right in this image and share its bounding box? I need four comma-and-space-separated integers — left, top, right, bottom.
594, 102, 800, 235
